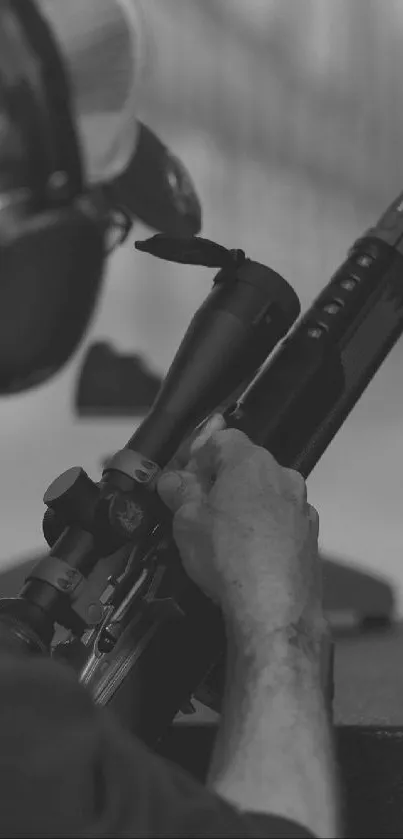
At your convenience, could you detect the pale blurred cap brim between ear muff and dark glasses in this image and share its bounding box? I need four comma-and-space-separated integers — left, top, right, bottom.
38, 0, 145, 185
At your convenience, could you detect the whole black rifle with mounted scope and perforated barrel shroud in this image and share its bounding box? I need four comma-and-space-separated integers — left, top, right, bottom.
0, 194, 403, 746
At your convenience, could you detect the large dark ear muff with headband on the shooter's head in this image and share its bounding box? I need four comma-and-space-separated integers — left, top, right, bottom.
0, 0, 107, 394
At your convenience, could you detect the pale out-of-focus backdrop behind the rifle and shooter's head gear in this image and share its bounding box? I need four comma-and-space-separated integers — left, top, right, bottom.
0, 0, 403, 615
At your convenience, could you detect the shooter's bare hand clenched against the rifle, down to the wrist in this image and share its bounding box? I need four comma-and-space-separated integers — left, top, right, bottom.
157, 415, 323, 637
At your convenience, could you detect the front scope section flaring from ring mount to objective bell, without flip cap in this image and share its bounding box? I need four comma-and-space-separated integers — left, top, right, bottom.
103, 253, 300, 492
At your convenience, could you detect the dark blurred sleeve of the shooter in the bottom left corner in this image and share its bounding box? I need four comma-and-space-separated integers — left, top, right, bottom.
0, 652, 318, 839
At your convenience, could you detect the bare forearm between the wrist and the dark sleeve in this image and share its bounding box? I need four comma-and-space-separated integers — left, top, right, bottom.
207, 627, 340, 837
